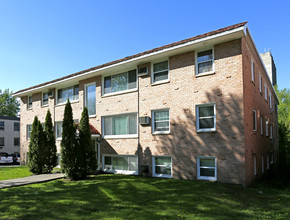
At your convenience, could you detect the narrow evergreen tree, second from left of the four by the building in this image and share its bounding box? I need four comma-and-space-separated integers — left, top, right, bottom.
44, 110, 57, 173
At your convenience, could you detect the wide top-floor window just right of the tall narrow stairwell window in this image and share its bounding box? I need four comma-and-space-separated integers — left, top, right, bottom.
104, 70, 137, 94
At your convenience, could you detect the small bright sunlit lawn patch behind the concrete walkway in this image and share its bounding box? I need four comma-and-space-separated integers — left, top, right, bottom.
0, 166, 32, 181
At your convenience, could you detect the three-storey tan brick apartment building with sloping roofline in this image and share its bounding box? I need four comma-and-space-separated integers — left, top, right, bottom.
14, 22, 278, 185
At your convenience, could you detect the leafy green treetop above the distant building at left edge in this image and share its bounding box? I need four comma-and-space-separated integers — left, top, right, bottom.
0, 89, 19, 116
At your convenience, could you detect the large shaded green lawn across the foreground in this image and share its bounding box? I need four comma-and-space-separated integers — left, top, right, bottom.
0, 175, 290, 219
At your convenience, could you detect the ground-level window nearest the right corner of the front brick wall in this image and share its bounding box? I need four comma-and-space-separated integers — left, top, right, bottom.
197, 157, 217, 180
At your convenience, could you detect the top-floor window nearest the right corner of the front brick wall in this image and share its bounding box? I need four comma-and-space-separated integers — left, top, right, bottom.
196, 49, 214, 75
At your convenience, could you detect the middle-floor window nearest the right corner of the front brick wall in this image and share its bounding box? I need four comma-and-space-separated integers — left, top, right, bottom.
196, 104, 216, 132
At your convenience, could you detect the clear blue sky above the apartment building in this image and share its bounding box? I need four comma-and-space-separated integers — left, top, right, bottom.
0, 0, 290, 92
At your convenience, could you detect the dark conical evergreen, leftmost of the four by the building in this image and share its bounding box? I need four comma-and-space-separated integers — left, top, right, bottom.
28, 116, 46, 174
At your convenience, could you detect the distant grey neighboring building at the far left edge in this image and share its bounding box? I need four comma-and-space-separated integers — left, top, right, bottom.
0, 116, 20, 154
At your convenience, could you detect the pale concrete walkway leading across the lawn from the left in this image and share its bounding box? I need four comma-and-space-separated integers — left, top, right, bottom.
0, 173, 64, 189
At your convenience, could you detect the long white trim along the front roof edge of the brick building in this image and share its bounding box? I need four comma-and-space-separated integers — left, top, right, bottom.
13, 24, 247, 96
